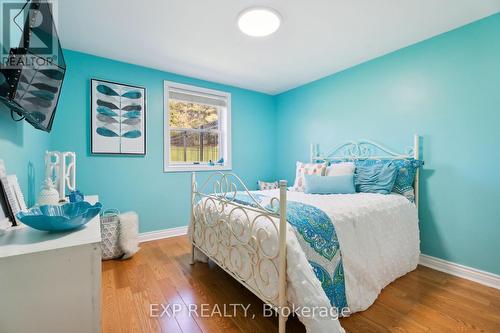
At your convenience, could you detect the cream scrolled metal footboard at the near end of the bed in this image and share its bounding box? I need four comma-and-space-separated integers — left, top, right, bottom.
190, 172, 288, 333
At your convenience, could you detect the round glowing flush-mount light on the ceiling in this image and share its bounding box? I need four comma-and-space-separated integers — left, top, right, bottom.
238, 7, 281, 37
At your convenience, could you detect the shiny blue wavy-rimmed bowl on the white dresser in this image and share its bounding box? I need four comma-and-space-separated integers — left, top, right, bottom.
16, 201, 102, 231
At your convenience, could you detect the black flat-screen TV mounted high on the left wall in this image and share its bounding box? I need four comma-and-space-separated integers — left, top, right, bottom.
0, 0, 66, 132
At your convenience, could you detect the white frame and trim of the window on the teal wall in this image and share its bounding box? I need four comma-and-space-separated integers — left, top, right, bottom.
163, 81, 232, 172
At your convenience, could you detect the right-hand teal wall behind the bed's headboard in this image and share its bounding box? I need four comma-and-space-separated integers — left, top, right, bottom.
276, 14, 500, 274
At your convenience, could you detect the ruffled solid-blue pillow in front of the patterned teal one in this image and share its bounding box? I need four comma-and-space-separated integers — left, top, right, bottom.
354, 161, 398, 194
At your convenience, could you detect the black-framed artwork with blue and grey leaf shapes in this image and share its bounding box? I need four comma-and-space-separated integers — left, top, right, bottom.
90, 79, 146, 155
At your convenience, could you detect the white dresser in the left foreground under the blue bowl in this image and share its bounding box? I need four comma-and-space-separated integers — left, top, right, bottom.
0, 196, 101, 333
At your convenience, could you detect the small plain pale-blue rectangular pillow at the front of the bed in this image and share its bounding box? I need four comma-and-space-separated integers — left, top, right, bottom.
304, 175, 356, 194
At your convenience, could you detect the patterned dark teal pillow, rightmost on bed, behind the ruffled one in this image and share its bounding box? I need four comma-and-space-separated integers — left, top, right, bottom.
356, 158, 424, 202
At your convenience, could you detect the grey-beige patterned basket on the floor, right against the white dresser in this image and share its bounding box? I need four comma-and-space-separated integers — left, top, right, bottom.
101, 209, 123, 260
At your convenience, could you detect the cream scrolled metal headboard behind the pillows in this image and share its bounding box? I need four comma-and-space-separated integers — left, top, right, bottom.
310, 134, 420, 209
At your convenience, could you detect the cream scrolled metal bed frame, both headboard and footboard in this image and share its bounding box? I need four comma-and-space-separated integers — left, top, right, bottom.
190, 134, 420, 333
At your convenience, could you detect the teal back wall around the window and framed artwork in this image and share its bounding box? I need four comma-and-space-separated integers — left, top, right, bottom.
50, 50, 275, 232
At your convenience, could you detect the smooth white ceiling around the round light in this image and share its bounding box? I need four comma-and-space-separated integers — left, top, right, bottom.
58, 0, 500, 94
